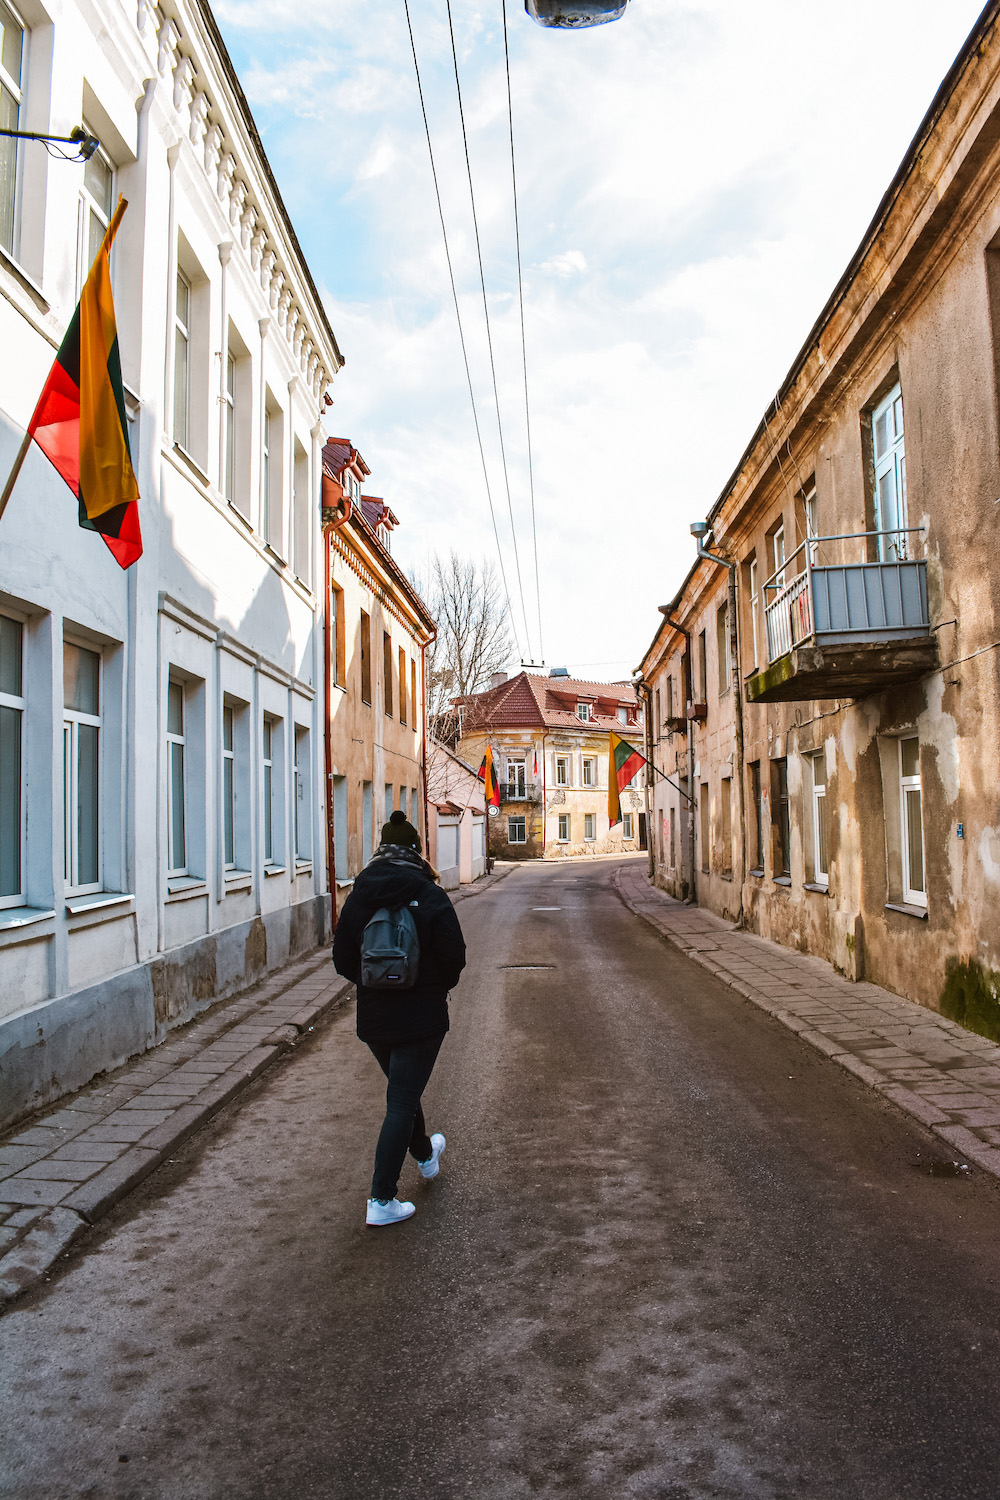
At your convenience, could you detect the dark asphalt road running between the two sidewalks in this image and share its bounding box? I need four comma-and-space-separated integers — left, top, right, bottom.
0, 861, 1000, 1500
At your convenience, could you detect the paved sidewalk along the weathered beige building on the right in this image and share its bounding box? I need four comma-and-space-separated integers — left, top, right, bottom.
615, 860, 1000, 1178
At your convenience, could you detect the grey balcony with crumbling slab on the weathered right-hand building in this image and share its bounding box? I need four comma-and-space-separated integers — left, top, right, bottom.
747, 527, 937, 704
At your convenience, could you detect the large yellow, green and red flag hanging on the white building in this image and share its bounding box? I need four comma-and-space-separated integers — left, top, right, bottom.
28, 198, 142, 567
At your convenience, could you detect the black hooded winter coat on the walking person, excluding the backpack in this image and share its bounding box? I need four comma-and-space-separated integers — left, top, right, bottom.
333, 845, 465, 1046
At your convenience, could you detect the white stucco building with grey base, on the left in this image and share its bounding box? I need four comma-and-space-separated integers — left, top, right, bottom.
0, 0, 342, 1121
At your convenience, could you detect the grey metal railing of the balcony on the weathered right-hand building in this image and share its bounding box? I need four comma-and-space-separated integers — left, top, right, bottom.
762, 527, 931, 662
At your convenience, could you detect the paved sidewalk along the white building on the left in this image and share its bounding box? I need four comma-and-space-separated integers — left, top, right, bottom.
0, 866, 516, 1307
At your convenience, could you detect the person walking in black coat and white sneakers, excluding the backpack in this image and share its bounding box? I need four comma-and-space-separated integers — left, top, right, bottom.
333, 810, 465, 1226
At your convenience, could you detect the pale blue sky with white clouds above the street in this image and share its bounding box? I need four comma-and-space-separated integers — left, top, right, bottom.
216, 0, 981, 681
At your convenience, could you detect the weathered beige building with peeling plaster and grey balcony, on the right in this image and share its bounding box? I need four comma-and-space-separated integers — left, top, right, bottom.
642, 5, 1000, 1035
